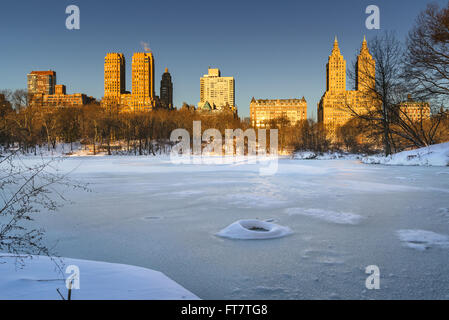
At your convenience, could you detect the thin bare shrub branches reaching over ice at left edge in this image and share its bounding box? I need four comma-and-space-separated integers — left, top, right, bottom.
0, 151, 87, 263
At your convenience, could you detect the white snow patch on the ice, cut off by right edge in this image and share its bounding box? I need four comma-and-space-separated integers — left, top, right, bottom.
397, 230, 449, 250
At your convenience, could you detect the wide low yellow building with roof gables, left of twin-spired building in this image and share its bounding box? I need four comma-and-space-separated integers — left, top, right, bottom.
249, 97, 307, 128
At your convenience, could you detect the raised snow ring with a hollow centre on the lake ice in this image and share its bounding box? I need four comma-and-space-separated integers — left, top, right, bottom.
217, 220, 292, 240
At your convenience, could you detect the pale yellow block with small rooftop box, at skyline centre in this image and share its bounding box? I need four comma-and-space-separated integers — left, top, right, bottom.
198, 68, 235, 112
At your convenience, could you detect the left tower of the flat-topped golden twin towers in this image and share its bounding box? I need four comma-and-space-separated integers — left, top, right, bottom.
104, 53, 125, 98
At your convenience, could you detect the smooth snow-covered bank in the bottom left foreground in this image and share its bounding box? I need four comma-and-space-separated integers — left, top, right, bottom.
0, 254, 198, 300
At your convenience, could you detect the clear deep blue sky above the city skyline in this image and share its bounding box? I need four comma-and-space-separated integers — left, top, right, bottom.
0, 0, 447, 117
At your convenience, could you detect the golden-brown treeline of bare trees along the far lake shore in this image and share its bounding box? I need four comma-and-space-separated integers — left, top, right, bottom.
0, 90, 449, 155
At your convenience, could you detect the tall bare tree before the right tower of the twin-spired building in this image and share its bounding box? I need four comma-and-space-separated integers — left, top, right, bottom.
346, 32, 441, 155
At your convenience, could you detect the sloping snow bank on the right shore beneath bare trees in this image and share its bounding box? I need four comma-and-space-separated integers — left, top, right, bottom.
362, 142, 449, 166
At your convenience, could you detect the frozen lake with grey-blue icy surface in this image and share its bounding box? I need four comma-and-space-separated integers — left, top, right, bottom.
23, 156, 449, 299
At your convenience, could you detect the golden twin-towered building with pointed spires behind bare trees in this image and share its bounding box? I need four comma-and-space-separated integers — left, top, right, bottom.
318, 38, 378, 140
